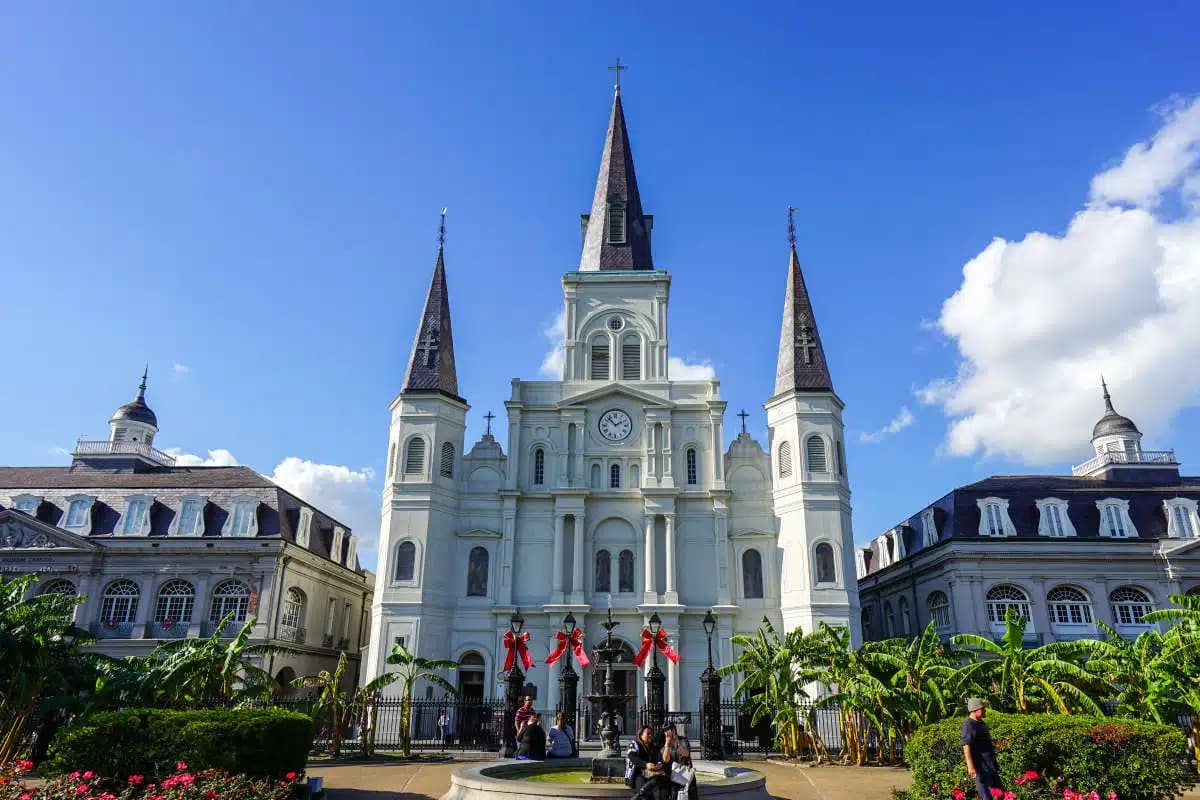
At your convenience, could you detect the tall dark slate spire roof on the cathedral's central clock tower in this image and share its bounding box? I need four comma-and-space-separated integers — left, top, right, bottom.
580, 84, 654, 272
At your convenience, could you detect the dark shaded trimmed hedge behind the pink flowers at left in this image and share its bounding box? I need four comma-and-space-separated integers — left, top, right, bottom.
48, 709, 313, 780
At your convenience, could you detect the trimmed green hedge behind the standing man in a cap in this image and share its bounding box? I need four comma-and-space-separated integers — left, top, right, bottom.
904, 712, 1195, 800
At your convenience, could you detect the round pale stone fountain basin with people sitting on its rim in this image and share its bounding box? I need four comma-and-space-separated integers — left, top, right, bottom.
442, 758, 770, 800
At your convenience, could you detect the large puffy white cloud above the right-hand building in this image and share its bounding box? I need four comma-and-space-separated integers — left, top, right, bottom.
917, 98, 1200, 463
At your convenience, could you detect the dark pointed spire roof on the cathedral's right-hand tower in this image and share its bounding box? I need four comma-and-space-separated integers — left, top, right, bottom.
775, 206, 833, 395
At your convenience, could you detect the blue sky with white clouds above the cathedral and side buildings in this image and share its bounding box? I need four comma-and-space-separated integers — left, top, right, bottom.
0, 2, 1200, 568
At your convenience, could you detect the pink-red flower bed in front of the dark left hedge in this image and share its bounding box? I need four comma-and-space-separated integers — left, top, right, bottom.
0, 762, 304, 800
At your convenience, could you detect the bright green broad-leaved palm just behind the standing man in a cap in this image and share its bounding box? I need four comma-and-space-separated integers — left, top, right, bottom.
952, 608, 1104, 716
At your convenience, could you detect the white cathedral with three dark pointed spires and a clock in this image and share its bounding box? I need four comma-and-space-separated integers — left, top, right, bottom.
365, 86, 860, 727
